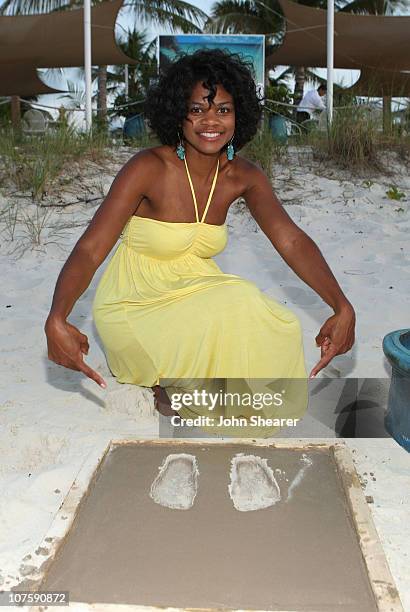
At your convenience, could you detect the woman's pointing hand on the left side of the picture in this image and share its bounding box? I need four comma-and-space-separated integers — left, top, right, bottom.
44, 317, 107, 389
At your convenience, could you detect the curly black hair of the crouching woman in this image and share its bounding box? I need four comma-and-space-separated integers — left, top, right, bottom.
144, 49, 262, 150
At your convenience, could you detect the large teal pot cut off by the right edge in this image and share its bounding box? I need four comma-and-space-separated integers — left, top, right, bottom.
383, 329, 410, 452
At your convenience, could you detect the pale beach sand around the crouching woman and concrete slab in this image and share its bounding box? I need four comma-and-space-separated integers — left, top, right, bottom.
0, 149, 410, 611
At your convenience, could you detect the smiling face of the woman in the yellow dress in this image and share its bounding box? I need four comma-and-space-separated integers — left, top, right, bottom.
182, 81, 235, 155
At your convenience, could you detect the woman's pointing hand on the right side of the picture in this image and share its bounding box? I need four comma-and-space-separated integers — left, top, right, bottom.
309, 306, 356, 378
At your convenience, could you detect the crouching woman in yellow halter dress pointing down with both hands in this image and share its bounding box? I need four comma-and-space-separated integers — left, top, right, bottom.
45, 50, 355, 430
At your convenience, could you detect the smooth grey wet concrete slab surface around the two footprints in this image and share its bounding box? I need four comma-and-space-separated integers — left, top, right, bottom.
41, 443, 377, 612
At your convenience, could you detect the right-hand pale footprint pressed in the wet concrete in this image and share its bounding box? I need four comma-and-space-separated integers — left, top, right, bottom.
228, 453, 281, 512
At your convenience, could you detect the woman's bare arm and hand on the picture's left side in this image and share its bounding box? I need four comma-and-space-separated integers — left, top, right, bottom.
44, 150, 162, 386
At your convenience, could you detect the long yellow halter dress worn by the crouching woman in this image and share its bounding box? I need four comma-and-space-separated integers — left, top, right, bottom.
93, 155, 307, 436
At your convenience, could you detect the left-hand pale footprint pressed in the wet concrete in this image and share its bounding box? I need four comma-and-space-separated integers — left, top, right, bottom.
149, 453, 199, 510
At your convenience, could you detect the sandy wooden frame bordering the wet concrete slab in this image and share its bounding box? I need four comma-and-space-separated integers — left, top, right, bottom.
24, 437, 404, 612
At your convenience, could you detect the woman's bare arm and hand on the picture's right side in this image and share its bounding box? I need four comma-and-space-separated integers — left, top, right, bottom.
243, 164, 355, 376
